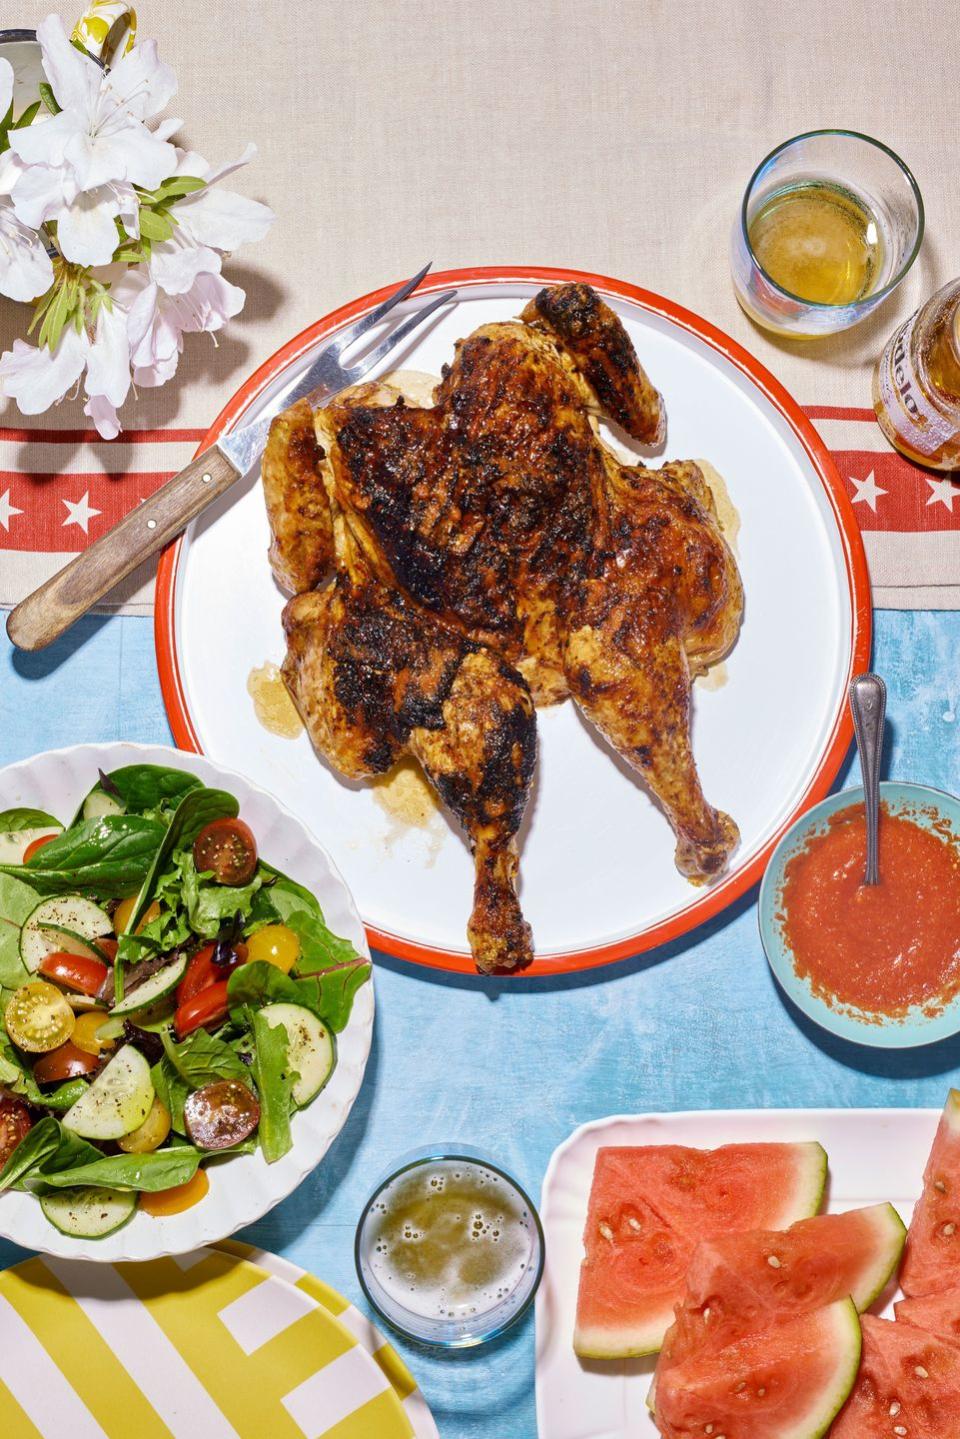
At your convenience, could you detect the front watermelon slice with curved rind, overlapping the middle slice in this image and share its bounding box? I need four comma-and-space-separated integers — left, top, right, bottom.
656, 1299, 861, 1439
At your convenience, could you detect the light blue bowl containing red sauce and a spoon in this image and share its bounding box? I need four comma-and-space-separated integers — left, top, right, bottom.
759, 780, 960, 1049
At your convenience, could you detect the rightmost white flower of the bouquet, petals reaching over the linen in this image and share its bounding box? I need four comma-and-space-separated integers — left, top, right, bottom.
150, 145, 275, 295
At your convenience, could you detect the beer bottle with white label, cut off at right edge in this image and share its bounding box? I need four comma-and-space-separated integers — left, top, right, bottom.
874, 279, 960, 471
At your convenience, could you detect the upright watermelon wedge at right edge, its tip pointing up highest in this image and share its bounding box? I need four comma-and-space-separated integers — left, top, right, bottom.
900, 1089, 960, 1295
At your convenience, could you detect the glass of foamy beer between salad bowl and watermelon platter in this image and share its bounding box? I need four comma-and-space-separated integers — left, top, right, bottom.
356, 1144, 544, 1348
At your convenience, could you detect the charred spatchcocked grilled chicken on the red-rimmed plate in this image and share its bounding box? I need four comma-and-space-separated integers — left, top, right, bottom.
263, 285, 743, 973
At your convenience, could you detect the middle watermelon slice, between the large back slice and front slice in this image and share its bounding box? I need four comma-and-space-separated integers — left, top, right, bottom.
656, 1204, 905, 1381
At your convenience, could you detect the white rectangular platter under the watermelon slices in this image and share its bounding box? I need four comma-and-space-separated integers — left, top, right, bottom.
537, 1109, 940, 1439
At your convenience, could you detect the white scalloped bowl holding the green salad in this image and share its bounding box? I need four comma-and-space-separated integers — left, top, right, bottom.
0, 743, 374, 1263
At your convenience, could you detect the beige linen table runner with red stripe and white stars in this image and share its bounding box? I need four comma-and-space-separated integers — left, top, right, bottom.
0, 0, 960, 613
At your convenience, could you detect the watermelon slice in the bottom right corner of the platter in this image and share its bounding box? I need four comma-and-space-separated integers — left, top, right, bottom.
829, 1314, 960, 1439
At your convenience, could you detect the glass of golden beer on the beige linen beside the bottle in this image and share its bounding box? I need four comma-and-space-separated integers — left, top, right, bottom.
731, 130, 924, 337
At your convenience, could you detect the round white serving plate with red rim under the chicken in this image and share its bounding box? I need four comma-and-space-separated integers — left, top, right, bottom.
157, 271, 869, 974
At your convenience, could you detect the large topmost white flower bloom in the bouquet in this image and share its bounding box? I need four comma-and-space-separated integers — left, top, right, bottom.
10, 16, 177, 265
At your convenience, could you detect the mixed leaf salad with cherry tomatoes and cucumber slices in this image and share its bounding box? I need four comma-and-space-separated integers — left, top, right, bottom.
0, 764, 370, 1238
